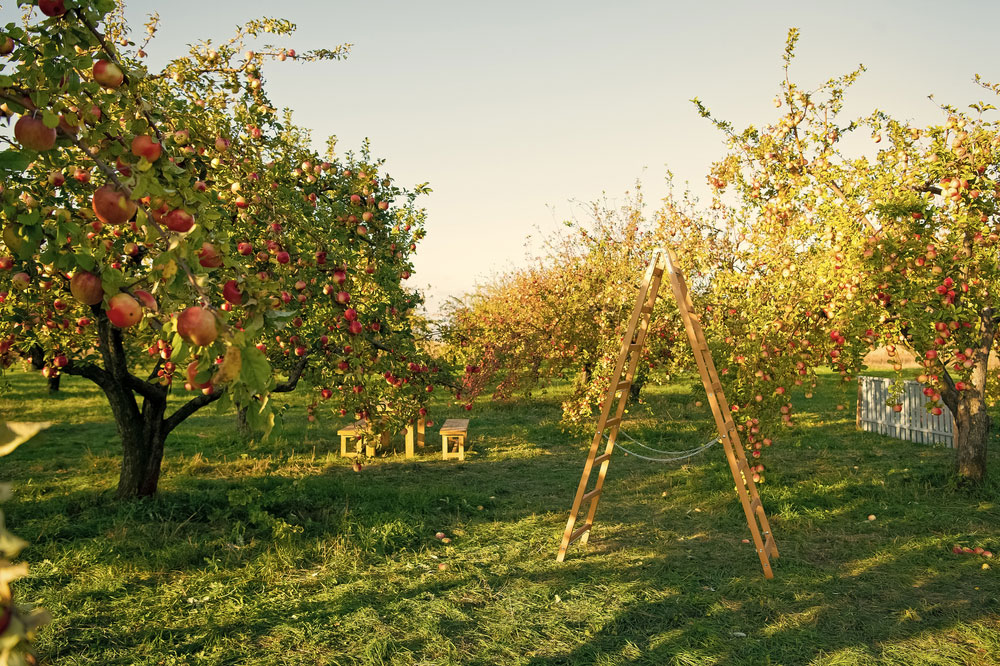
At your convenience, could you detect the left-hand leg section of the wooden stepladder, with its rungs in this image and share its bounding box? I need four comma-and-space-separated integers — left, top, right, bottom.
556, 250, 665, 562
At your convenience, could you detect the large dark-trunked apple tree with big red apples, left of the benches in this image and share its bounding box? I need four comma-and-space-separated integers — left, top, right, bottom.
0, 0, 452, 497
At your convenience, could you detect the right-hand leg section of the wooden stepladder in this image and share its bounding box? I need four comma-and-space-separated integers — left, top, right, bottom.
667, 250, 777, 578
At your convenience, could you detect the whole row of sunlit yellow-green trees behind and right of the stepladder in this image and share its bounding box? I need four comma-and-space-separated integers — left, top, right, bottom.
449, 30, 1000, 482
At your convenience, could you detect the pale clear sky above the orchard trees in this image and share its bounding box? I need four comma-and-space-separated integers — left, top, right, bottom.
0, 0, 1000, 312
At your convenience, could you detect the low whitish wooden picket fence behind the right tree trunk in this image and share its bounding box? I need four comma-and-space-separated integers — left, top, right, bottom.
857, 377, 955, 447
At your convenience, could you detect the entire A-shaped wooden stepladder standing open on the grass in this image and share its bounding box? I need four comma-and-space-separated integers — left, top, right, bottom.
556, 249, 778, 578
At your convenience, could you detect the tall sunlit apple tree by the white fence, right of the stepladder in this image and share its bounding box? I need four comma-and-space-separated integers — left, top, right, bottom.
684, 30, 1000, 482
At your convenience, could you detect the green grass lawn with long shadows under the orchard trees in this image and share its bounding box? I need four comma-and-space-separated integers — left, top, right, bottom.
0, 366, 1000, 666
